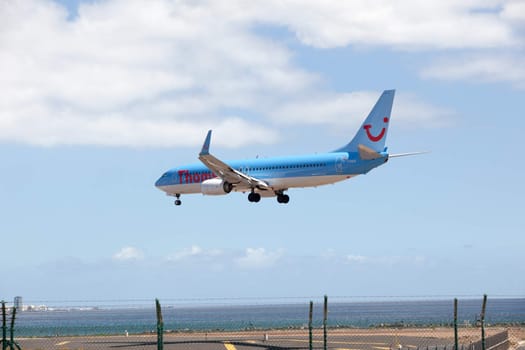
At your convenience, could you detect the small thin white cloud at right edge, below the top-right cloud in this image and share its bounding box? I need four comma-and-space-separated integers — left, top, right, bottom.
421, 54, 525, 88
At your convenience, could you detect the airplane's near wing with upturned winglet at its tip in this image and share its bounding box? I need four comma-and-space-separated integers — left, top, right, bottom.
199, 130, 271, 190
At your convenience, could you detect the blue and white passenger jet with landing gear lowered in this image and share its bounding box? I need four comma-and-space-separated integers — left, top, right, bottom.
155, 90, 425, 206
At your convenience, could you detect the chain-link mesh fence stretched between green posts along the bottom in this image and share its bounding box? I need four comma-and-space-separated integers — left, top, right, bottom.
2, 298, 525, 350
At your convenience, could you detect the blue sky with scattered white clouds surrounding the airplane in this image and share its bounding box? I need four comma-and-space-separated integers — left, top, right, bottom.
0, 0, 525, 302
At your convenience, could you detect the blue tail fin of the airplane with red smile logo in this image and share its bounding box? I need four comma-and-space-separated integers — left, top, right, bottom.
335, 90, 396, 154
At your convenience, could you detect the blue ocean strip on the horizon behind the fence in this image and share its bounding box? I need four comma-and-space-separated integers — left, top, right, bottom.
8, 298, 525, 337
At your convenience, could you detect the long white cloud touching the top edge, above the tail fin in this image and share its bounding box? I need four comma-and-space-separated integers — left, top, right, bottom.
246, 0, 518, 49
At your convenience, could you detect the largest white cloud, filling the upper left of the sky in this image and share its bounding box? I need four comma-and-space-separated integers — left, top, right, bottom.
0, 0, 315, 147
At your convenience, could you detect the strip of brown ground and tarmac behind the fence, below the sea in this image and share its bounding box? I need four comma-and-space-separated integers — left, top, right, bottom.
11, 327, 525, 350
